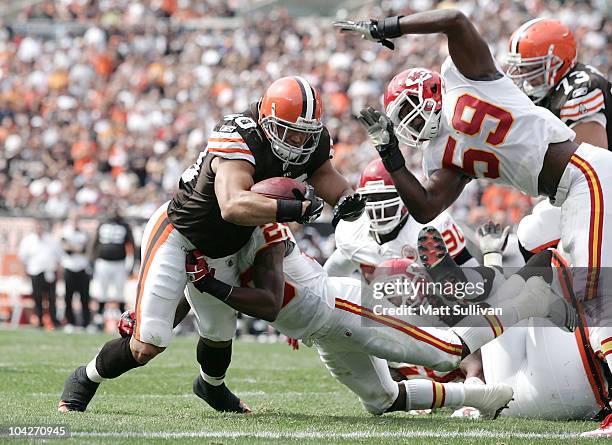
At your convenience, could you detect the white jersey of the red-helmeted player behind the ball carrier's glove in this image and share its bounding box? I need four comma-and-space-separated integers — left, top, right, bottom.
336, 211, 465, 278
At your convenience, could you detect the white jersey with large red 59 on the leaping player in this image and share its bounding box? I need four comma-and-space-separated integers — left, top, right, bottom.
423, 57, 575, 196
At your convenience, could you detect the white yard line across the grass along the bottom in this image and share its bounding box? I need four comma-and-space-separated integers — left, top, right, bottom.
70, 430, 579, 439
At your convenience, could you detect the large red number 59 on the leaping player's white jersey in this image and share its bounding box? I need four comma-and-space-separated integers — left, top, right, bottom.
442, 94, 514, 179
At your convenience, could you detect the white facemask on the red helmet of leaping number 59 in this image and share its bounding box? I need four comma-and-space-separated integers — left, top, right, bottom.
386, 90, 441, 148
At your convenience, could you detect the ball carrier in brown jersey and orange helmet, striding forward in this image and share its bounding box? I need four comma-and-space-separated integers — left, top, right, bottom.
59, 76, 364, 413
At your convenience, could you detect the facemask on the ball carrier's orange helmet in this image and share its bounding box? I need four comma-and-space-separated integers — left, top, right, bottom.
261, 107, 323, 165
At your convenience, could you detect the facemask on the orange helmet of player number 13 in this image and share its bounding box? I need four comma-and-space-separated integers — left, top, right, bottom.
506, 45, 563, 103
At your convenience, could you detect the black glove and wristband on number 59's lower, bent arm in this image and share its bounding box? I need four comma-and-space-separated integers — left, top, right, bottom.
357, 107, 406, 173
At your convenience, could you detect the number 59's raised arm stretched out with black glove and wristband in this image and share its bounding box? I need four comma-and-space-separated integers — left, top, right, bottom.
335, 9, 498, 80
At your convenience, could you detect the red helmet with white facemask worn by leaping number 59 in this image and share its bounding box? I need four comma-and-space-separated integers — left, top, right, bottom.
384, 68, 442, 147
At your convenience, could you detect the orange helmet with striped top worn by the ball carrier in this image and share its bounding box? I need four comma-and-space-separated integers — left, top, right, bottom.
259, 76, 323, 165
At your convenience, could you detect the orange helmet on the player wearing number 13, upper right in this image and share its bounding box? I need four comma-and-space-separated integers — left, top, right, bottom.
507, 19, 576, 103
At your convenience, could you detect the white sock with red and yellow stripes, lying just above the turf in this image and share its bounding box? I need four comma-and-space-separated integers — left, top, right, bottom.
404, 379, 464, 411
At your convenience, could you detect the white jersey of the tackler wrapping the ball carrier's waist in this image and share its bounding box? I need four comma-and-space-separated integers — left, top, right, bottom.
238, 223, 334, 339
